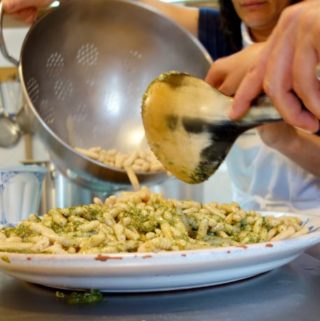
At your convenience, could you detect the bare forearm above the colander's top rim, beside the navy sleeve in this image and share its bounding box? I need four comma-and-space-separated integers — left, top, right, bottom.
139, 0, 199, 36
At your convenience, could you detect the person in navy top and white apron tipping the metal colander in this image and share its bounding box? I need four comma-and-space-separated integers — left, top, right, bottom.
3, 0, 320, 213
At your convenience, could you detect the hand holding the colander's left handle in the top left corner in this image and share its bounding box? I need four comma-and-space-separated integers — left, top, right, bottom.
2, 0, 53, 23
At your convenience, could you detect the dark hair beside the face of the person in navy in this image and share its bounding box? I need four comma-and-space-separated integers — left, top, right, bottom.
219, 0, 301, 49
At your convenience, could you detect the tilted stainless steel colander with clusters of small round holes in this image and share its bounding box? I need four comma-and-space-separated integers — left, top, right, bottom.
2, 0, 210, 190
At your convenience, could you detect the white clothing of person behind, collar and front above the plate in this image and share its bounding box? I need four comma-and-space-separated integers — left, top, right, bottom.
226, 24, 320, 215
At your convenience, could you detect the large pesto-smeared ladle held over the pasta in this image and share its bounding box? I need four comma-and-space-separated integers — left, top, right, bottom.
142, 72, 290, 184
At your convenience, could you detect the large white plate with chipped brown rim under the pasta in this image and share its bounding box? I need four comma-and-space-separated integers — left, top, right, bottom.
0, 213, 320, 292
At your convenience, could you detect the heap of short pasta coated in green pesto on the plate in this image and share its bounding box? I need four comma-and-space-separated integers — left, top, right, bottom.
0, 188, 307, 254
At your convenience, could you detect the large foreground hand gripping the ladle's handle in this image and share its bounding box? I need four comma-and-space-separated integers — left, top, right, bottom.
230, 0, 320, 132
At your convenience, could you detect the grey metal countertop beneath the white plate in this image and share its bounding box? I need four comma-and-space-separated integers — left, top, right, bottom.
0, 254, 320, 321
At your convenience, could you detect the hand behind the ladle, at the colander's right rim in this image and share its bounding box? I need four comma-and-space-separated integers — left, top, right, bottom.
205, 43, 264, 96
